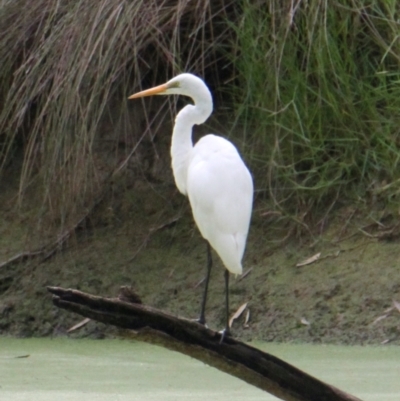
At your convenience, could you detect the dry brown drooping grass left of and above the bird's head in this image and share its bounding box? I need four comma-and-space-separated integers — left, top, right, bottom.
0, 0, 231, 230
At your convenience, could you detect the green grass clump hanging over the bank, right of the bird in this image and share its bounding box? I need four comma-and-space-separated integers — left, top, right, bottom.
228, 0, 400, 222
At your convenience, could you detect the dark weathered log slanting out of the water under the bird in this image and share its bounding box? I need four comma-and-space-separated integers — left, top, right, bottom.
48, 287, 361, 401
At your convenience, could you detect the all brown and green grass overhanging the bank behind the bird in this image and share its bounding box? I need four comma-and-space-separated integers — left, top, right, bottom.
0, 0, 400, 230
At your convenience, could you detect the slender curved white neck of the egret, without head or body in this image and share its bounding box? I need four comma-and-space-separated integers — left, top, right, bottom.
171, 88, 213, 195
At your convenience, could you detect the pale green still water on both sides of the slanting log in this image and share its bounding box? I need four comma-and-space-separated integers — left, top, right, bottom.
0, 338, 400, 401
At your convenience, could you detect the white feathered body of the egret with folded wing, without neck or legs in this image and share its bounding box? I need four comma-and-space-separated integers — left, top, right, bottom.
187, 135, 253, 274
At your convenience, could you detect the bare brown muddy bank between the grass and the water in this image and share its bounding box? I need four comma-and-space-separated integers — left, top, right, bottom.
0, 181, 400, 344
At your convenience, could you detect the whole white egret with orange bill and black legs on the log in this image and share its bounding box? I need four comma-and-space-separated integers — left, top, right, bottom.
129, 73, 253, 334
